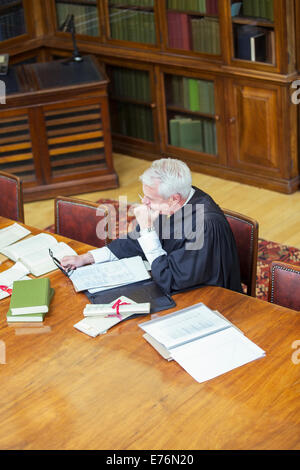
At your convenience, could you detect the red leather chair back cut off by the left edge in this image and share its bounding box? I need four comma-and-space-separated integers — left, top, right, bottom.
0, 171, 24, 222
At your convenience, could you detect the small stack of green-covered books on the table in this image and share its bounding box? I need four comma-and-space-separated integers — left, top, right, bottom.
6, 278, 54, 323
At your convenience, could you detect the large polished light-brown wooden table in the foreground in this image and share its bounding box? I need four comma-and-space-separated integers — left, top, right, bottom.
0, 218, 300, 450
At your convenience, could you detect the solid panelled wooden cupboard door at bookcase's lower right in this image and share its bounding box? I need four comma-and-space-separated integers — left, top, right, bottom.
226, 78, 297, 192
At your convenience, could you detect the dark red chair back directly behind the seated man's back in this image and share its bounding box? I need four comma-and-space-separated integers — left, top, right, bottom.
222, 209, 258, 297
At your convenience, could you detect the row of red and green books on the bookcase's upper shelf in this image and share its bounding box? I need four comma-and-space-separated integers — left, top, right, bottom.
167, 11, 220, 55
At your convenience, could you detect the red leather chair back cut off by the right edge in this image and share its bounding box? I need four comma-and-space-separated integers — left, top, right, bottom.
268, 261, 300, 310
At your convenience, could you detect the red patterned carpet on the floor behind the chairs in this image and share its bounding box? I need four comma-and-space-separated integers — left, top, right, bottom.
45, 199, 300, 300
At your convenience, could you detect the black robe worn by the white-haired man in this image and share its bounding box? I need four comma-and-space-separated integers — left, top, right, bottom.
108, 187, 242, 294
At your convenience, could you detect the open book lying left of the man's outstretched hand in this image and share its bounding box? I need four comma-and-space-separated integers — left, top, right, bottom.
0, 233, 77, 276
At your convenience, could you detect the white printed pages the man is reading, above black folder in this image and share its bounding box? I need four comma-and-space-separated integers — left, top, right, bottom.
70, 256, 150, 293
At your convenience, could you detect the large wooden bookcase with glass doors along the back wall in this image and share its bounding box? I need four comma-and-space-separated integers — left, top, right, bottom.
0, 0, 300, 193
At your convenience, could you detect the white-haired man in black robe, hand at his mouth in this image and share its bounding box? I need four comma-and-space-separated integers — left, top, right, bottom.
62, 158, 242, 294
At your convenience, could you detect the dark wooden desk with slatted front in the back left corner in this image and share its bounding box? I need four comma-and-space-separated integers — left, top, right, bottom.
0, 56, 118, 201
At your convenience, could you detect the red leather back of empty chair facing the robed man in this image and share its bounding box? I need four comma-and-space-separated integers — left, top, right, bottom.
54, 196, 108, 248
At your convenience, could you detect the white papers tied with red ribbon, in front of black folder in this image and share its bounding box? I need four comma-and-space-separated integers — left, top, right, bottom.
74, 296, 150, 338
